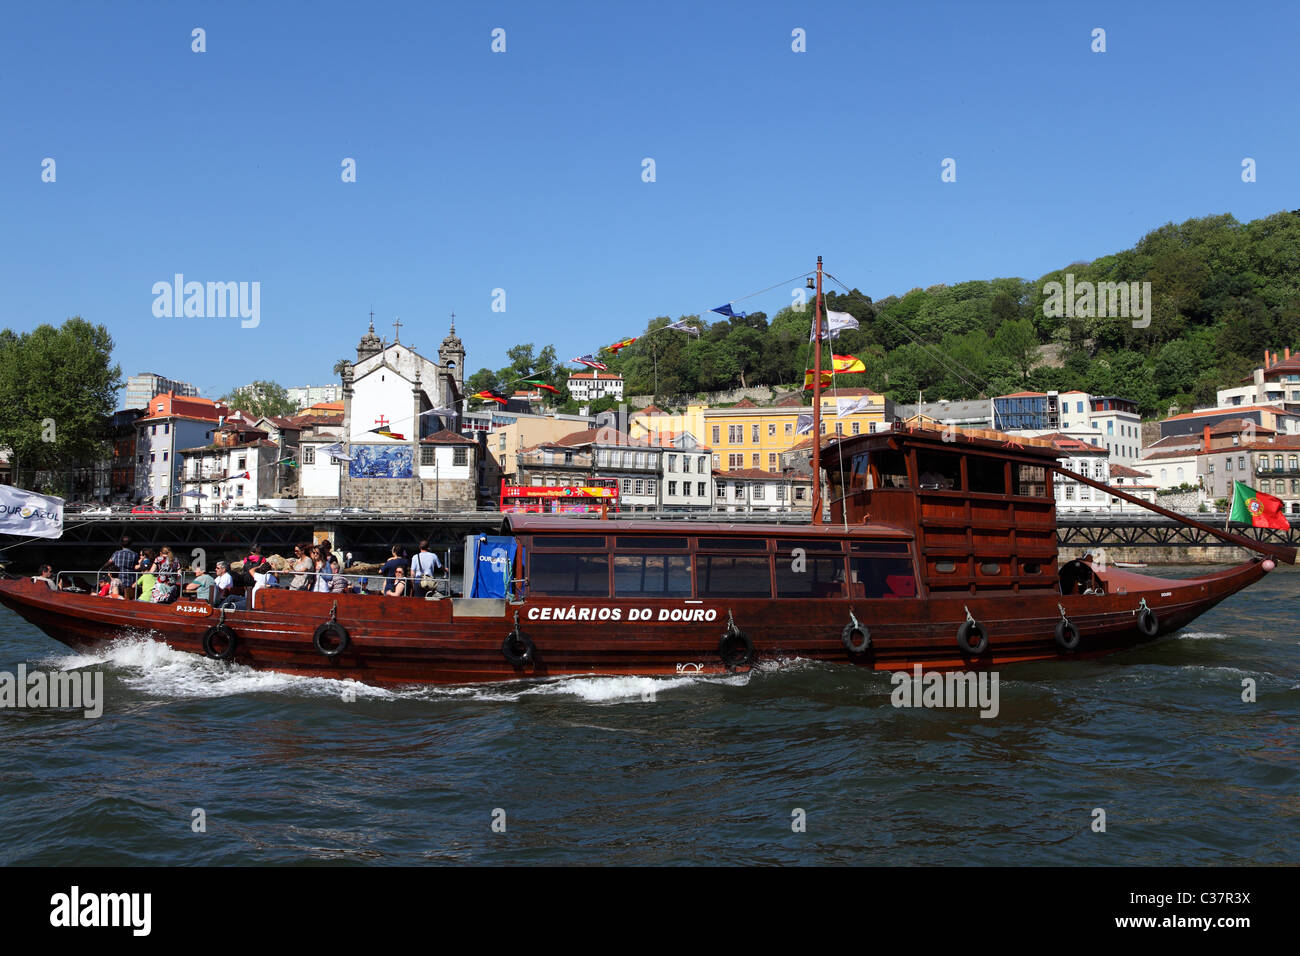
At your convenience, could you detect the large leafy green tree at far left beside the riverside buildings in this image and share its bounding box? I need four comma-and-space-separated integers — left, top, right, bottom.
0, 316, 122, 492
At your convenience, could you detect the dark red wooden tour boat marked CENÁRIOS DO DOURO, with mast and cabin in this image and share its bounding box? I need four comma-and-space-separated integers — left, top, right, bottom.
0, 259, 1296, 684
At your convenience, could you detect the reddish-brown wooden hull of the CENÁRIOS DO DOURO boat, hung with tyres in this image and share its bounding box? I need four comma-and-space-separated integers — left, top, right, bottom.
0, 561, 1271, 685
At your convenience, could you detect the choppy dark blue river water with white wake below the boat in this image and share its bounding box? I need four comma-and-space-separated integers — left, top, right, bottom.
0, 570, 1300, 865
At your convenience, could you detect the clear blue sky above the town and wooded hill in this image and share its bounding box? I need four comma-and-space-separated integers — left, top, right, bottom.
0, 0, 1300, 395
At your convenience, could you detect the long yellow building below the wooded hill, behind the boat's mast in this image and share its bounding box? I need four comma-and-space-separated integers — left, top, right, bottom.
629, 388, 893, 473
